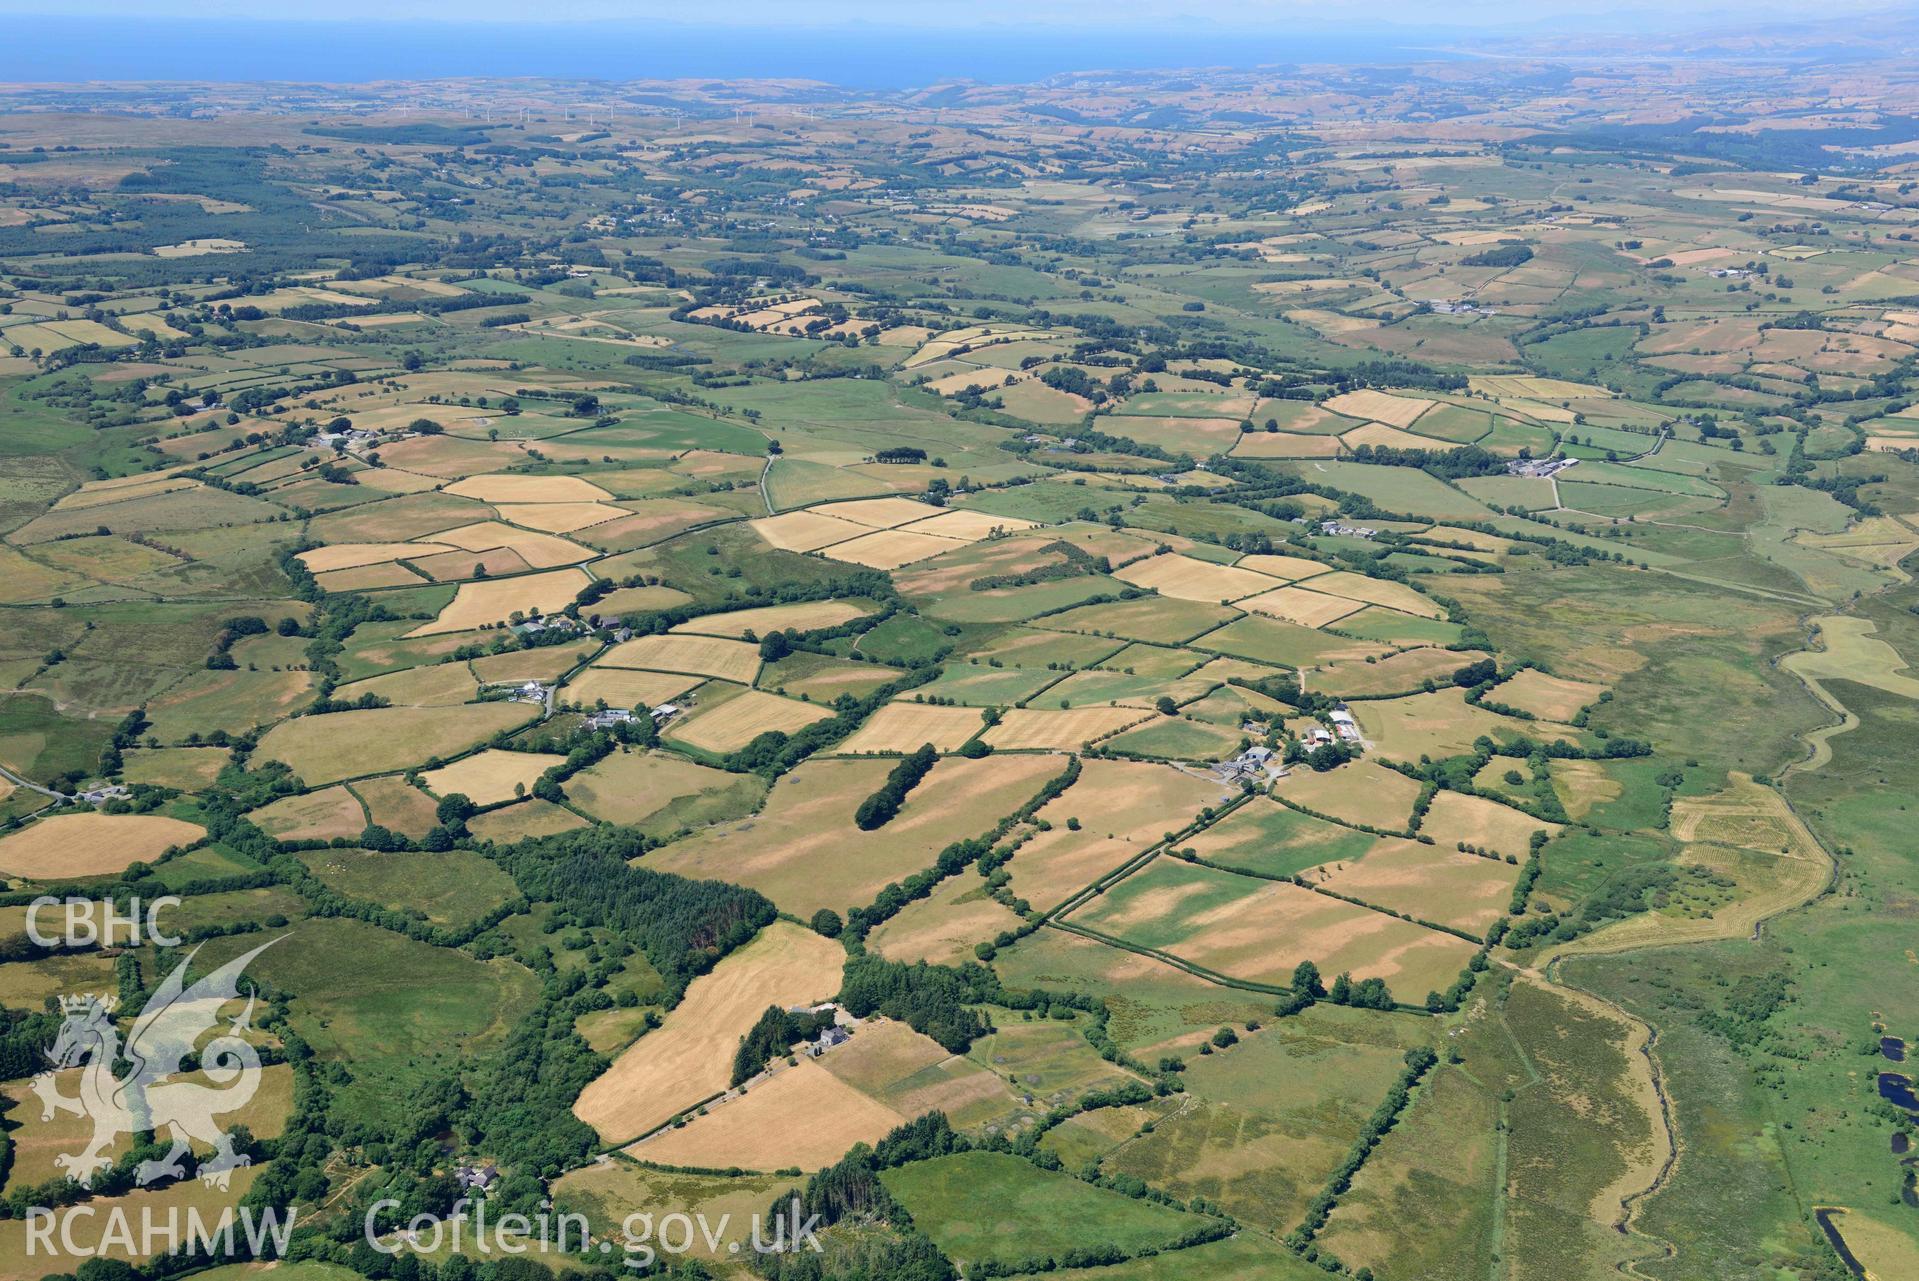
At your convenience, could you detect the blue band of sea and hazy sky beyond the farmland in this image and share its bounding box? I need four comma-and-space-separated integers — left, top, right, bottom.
0, 0, 1884, 90
